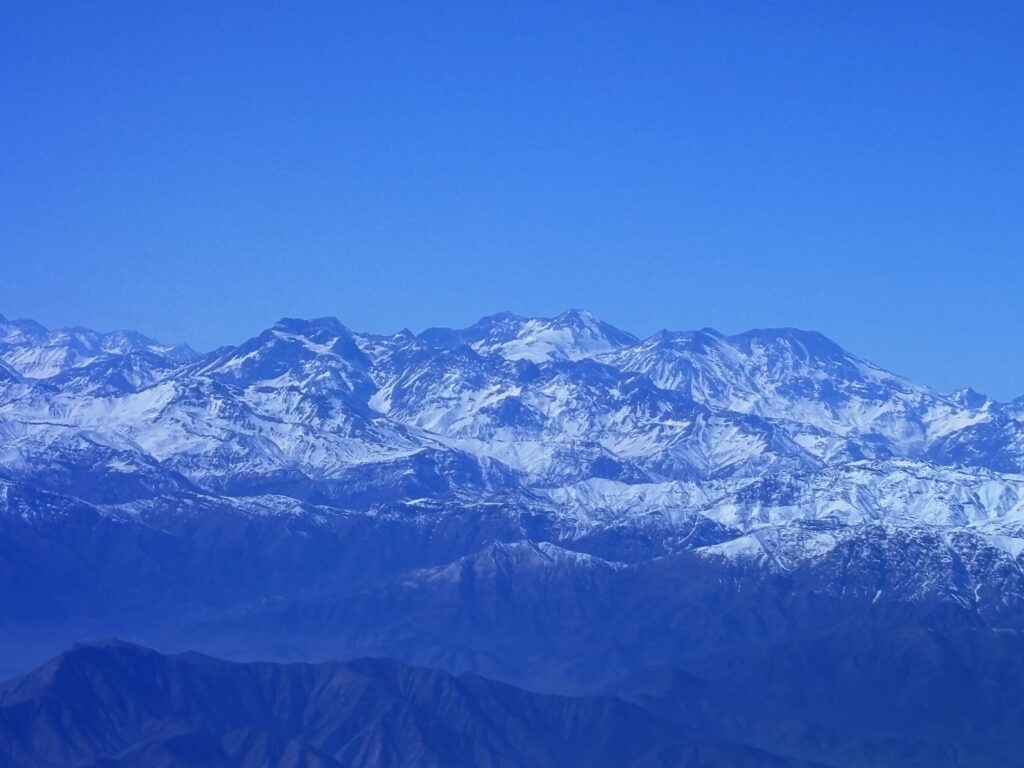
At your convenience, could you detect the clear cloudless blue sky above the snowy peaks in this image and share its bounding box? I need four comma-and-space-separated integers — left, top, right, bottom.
0, 0, 1024, 397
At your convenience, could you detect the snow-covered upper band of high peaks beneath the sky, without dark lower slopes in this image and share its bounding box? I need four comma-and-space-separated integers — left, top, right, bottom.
0, 310, 1024, 532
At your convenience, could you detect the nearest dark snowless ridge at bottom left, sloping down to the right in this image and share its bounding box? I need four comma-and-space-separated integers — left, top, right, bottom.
0, 642, 811, 768
